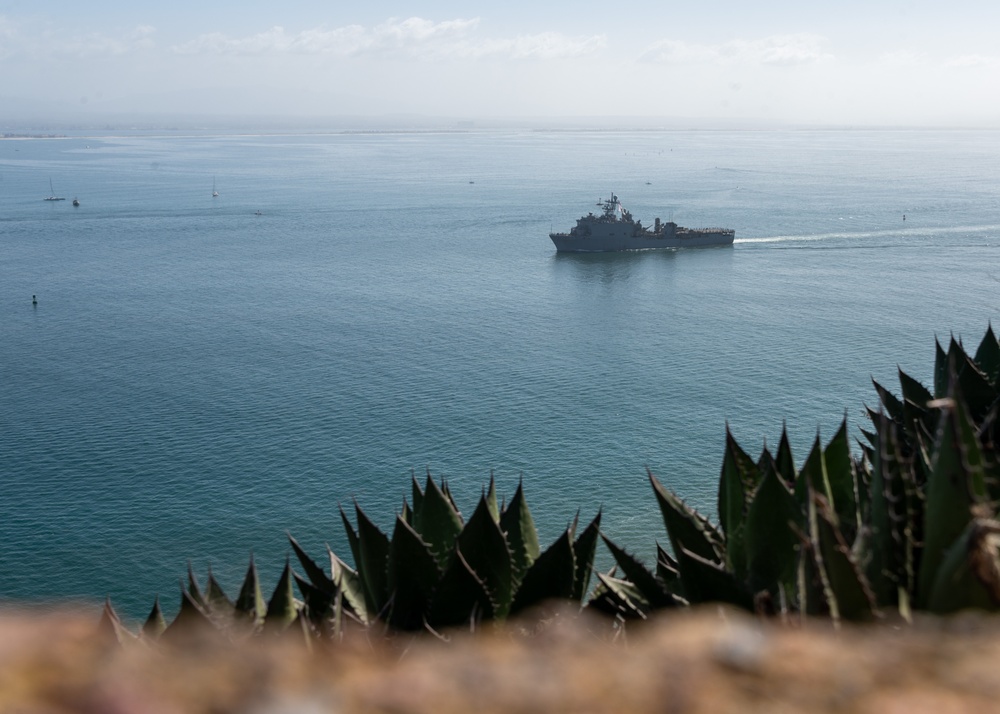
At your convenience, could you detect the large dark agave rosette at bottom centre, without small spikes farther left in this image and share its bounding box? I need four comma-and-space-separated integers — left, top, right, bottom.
289, 474, 601, 631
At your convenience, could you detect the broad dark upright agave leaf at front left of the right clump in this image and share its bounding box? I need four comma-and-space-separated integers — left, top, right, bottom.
748, 456, 805, 595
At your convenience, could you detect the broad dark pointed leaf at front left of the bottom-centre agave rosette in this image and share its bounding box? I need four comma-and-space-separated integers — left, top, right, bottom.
388, 518, 441, 630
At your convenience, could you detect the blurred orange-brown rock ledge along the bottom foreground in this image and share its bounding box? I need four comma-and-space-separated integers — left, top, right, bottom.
0, 609, 1000, 714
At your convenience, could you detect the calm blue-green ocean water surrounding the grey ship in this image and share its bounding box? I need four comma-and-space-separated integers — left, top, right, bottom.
0, 131, 1000, 618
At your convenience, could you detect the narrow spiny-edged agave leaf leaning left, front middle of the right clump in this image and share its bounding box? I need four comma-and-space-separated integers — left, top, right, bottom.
809, 489, 875, 620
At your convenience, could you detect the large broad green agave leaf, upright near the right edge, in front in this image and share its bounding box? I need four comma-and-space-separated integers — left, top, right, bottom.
917, 394, 987, 607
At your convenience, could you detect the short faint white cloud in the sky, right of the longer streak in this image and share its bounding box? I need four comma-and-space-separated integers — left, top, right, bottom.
639, 33, 833, 66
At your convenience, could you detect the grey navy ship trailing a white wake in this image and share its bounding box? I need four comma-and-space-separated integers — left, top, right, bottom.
549, 194, 736, 253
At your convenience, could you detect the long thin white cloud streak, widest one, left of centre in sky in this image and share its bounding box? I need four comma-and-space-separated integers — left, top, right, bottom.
173, 17, 606, 59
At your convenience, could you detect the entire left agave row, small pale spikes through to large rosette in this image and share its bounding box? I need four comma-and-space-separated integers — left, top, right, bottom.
111, 474, 601, 641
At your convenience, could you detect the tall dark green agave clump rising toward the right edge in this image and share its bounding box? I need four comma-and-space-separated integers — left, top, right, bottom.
601, 328, 1000, 619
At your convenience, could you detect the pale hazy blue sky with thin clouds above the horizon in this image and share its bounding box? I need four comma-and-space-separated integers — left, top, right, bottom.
0, 0, 1000, 126
